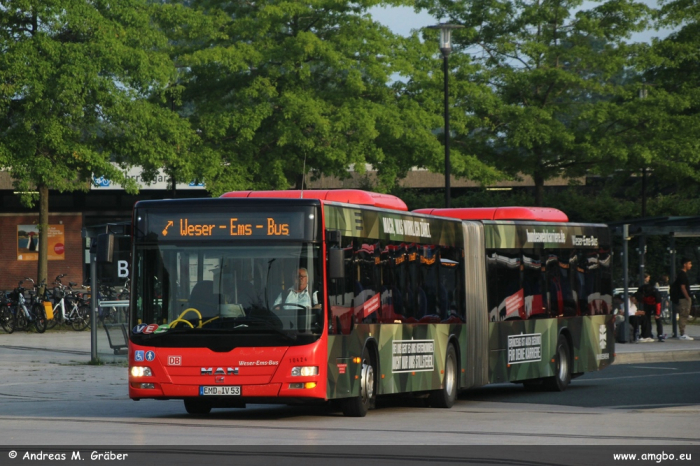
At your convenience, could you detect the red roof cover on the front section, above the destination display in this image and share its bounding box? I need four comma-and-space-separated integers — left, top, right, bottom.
221, 189, 408, 211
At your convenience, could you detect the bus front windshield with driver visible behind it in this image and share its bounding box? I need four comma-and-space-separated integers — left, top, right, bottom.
131, 242, 324, 344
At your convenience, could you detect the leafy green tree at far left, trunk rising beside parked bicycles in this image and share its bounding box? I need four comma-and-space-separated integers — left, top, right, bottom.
0, 0, 196, 281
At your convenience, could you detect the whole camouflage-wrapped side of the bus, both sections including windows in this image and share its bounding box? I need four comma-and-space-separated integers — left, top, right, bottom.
324, 203, 614, 399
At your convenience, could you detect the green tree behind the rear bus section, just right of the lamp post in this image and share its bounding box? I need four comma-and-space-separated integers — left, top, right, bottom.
418, 0, 648, 205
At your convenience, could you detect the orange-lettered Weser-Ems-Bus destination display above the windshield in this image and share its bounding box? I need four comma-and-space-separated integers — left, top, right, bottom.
148, 212, 305, 241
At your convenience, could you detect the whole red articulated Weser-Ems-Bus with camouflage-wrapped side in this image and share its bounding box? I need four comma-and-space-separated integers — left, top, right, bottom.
129, 190, 614, 416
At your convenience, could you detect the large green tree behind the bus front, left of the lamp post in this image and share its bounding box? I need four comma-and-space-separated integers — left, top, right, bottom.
169, 0, 494, 194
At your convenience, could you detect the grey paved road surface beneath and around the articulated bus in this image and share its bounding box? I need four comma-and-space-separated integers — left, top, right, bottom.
0, 326, 700, 445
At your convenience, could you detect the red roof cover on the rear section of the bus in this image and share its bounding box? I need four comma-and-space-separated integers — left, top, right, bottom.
413, 207, 569, 222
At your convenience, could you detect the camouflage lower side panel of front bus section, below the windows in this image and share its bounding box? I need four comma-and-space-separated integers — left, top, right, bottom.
328, 324, 466, 399
